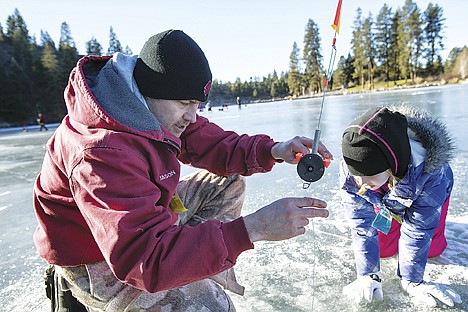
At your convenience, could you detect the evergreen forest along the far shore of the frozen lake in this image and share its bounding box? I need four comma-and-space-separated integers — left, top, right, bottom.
0, 0, 468, 127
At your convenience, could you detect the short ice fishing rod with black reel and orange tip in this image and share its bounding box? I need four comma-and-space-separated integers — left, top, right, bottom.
296, 0, 342, 188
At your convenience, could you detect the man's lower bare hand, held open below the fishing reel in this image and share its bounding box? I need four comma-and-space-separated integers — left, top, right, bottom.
244, 197, 328, 243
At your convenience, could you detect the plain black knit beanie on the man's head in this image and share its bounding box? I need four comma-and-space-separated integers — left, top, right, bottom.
133, 30, 212, 102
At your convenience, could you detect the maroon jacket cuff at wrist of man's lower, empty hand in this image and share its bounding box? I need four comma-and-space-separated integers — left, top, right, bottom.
221, 217, 254, 264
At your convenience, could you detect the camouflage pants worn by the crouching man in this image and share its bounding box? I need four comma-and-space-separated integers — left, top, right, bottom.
56, 170, 245, 312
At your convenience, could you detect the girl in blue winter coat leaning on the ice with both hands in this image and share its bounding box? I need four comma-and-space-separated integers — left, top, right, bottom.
340, 106, 461, 306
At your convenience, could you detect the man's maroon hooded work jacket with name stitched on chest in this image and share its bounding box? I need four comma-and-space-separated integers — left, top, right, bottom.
34, 55, 275, 292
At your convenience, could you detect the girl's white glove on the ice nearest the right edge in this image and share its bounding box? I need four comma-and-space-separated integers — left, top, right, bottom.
401, 279, 462, 307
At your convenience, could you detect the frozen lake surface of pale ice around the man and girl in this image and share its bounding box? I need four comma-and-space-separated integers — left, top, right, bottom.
0, 85, 468, 312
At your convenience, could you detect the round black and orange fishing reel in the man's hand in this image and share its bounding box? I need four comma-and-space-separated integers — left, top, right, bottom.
296, 153, 331, 182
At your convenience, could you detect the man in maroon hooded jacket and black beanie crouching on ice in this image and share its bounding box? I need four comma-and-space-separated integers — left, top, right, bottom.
34, 30, 332, 311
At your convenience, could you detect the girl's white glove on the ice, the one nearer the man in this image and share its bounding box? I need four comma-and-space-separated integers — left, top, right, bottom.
343, 272, 383, 303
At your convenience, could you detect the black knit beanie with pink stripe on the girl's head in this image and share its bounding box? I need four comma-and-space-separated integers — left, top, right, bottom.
341, 108, 411, 178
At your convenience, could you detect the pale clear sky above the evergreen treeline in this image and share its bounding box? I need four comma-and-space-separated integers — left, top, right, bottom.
0, 0, 468, 82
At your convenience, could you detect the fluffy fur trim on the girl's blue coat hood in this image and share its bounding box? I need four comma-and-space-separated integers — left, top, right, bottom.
389, 103, 455, 172
